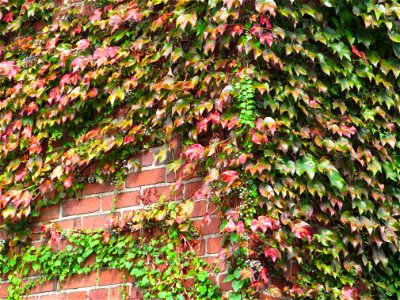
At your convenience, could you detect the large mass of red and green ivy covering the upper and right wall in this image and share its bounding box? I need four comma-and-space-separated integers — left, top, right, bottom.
0, 0, 400, 299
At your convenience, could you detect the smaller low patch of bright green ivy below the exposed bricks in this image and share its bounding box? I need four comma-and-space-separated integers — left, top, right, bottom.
0, 202, 219, 300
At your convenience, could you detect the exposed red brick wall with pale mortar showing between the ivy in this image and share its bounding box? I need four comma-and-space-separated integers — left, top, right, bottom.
0, 149, 229, 300
